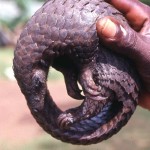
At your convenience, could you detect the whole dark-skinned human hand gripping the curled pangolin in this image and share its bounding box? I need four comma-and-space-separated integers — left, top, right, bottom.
97, 0, 150, 110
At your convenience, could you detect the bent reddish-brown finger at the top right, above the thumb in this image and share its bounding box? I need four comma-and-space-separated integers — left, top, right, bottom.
106, 0, 150, 31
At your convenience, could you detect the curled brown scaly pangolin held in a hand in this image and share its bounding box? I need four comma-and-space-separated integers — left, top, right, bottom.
13, 0, 139, 145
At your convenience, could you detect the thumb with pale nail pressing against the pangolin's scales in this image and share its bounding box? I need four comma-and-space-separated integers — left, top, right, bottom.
96, 17, 150, 62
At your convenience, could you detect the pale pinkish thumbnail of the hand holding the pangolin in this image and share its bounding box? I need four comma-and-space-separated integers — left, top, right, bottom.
97, 18, 117, 38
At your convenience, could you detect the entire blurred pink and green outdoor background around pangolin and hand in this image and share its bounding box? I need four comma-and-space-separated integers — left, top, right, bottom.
0, 0, 150, 150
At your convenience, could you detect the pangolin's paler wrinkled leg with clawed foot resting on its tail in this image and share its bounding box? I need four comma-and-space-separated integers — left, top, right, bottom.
58, 69, 110, 128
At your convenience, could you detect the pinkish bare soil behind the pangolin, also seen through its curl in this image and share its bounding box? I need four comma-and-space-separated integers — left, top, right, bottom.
0, 80, 79, 143
